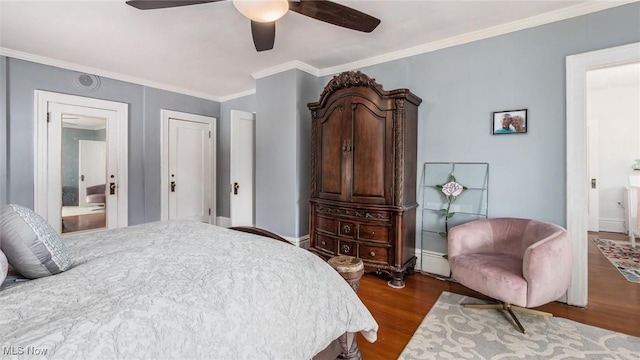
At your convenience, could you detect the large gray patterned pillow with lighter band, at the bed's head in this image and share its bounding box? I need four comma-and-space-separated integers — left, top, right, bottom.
0, 204, 71, 279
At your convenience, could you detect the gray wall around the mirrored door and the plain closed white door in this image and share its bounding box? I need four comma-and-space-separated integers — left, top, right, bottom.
0, 57, 220, 224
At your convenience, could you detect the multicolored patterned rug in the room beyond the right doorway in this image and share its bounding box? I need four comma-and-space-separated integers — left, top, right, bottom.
593, 238, 640, 283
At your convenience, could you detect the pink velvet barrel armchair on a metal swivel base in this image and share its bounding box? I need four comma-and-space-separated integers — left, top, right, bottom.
448, 218, 572, 333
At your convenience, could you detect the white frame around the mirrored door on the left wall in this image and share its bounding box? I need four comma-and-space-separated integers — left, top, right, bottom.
33, 90, 129, 231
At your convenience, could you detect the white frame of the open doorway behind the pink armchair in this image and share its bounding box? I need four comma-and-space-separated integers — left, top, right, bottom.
566, 42, 640, 307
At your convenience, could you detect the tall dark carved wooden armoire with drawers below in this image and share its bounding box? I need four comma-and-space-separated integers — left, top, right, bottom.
308, 71, 422, 287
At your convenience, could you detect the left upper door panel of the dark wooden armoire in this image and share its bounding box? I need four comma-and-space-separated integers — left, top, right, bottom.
318, 108, 345, 200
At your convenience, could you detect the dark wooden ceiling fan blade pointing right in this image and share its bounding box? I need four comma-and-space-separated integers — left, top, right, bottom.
289, 0, 380, 32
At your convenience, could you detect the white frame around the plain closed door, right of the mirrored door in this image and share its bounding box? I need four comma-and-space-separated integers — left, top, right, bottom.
160, 109, 217, 224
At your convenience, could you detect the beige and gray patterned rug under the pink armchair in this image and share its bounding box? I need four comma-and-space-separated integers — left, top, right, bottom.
398, 291, 640, 360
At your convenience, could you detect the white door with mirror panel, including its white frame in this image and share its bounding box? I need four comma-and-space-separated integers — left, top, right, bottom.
34, 91, 128, 233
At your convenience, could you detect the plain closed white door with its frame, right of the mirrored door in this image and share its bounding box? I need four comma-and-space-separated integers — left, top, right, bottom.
161, 110, 215, 223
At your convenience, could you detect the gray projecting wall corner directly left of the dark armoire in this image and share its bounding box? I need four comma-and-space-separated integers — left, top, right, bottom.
256, 70, 320, 237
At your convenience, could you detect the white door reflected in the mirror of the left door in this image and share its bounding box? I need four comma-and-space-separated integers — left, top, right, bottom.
78, 140, 107, 207
